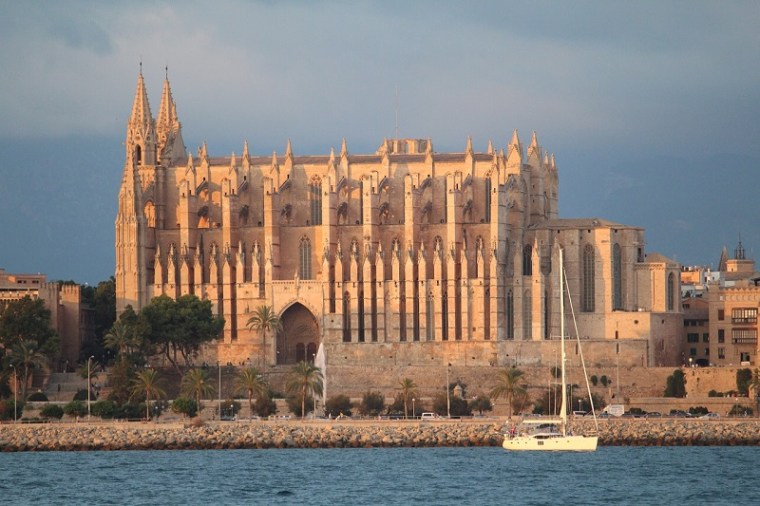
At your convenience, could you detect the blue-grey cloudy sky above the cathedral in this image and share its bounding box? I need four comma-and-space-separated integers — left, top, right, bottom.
0, 0, 760, 284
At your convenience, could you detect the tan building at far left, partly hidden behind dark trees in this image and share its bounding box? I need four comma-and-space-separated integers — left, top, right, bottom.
0, 268, 94, 370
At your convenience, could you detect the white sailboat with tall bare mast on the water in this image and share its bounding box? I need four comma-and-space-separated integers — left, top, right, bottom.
502, 248, 599, 452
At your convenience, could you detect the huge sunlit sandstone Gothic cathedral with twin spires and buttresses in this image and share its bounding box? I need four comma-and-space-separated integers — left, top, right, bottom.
115, 71, 683, 368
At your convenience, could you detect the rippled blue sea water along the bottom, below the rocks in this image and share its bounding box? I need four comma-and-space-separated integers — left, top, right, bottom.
0, 447, 760, 505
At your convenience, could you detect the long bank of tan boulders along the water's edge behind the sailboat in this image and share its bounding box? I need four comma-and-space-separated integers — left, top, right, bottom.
0, 420, 760, 452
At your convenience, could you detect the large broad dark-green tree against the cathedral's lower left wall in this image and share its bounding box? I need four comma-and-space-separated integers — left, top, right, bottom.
140, 295, 224, 374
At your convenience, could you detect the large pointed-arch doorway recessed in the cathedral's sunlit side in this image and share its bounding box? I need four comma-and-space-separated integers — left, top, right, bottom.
277, 303, 319, 365
